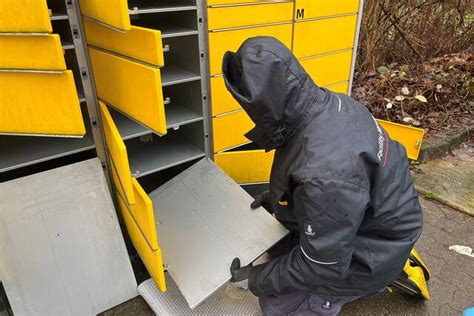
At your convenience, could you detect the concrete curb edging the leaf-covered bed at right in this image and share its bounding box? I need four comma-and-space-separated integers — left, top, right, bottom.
416, 125, 474, 163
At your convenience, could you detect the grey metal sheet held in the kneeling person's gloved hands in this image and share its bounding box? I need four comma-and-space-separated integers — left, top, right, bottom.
150, 159, 287, 308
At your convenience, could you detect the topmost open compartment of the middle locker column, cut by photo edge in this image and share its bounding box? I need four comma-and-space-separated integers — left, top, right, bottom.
128, 0, 197, 15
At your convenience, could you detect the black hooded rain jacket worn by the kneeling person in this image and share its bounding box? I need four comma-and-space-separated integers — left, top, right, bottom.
223, 37, 422, 296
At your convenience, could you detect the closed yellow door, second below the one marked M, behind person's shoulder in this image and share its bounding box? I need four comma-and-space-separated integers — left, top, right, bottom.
300, 50, 352, 87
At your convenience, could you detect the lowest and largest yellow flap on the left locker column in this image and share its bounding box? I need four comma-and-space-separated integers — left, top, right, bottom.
0, 70, 86, 136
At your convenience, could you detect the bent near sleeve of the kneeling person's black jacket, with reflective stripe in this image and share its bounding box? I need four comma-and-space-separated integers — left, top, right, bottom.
249, 178, 370, 296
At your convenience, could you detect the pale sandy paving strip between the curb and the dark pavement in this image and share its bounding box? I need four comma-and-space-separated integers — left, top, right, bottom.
413, 140, 474, 216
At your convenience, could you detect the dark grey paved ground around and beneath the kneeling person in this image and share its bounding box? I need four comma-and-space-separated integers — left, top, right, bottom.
104, 198, 474, 316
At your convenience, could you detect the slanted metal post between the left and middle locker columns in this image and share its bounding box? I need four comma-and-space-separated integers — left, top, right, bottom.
65, 0, 111, 188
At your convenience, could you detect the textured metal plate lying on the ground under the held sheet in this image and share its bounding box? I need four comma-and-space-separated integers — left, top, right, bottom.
138, 273, 261, 316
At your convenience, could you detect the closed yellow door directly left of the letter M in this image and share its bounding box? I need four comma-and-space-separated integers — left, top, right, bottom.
207, 2, 293, 30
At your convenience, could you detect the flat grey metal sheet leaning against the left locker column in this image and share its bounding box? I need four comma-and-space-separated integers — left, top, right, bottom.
0, 159, 137, 316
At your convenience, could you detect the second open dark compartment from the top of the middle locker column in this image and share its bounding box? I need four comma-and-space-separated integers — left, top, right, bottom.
131, 11, 198, 38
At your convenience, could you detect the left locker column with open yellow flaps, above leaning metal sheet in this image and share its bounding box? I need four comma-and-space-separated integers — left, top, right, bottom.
0, 0, 105, 181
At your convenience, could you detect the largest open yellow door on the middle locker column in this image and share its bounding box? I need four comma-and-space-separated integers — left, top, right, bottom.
89, 48, 166, 135
